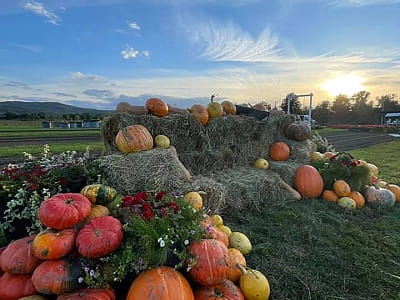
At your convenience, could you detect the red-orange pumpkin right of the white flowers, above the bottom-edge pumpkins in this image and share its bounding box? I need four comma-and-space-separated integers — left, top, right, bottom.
187, 239, 229, 286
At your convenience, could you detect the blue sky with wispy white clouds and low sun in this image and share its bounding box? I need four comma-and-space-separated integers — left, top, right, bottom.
0, 0, 400, 109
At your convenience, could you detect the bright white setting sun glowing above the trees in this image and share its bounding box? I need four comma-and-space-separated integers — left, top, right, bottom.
321, 74, 365, 97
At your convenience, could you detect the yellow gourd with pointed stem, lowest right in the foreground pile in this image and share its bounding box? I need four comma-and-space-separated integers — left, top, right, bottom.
238, 265, 270, 300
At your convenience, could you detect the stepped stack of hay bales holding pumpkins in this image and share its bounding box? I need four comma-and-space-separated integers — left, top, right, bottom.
100, 113, 311, 212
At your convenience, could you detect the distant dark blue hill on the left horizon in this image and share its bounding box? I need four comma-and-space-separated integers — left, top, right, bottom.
0, 101, 114, 116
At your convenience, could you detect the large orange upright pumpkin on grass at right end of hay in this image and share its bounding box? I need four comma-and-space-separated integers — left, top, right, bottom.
294, 165, 324, 199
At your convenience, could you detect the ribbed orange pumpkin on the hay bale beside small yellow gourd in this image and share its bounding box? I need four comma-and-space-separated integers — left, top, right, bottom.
115, 125, 153, 153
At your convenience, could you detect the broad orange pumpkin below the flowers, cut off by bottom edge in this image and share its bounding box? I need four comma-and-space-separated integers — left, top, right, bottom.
126, 266, 194, 300
